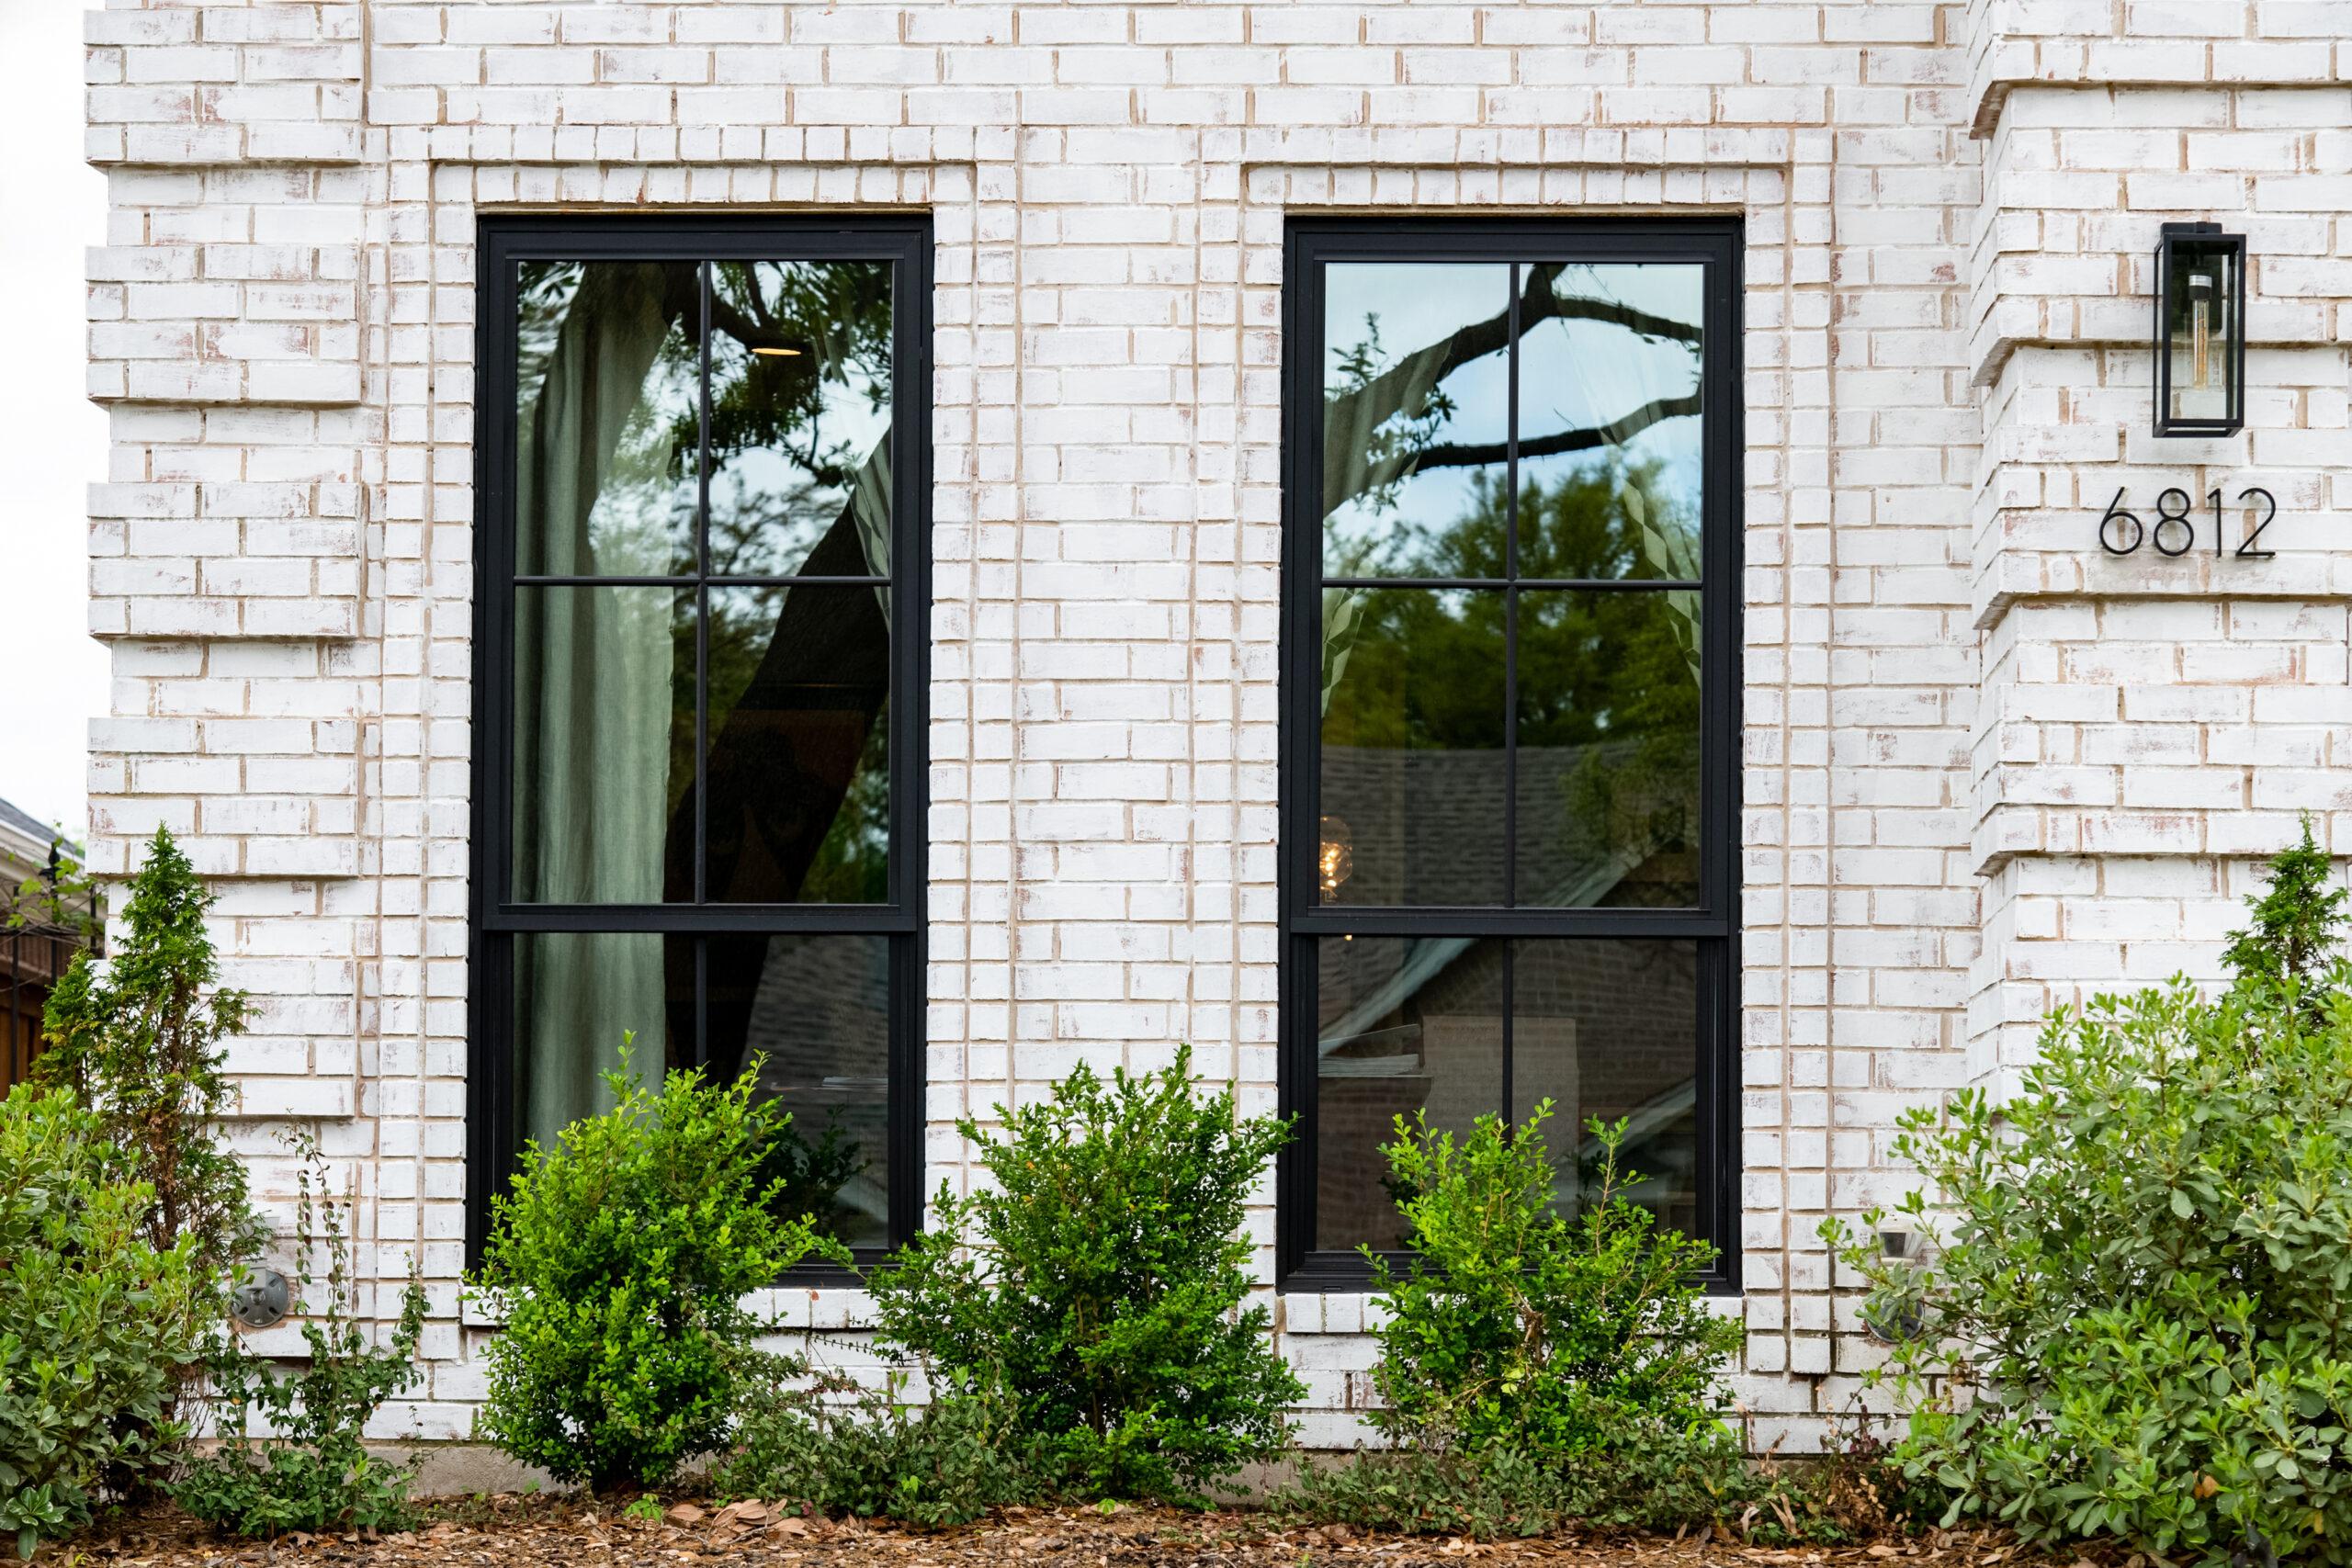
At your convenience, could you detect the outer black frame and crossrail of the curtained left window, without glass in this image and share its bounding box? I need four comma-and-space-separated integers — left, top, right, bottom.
466, 214, 932, 1286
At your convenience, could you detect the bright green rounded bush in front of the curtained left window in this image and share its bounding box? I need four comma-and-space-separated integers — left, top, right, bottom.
473, 1048, 847, 1488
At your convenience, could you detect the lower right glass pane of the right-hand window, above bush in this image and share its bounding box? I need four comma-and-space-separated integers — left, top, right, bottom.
1510, 941, 1698, 1235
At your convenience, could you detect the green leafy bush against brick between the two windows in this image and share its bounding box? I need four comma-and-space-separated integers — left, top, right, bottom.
870, 1051, 1306, 1500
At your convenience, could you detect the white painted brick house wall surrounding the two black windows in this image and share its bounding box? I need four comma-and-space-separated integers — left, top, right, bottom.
74, 0, 2352, 1443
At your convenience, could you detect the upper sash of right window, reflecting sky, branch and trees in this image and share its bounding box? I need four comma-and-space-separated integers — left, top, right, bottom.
1284, 221, 1738, 936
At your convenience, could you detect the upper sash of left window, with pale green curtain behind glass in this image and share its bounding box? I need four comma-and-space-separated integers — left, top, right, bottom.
478, 216, 929, 929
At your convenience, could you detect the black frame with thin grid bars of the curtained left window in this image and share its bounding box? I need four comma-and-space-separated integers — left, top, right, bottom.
468, 219, 932, 1283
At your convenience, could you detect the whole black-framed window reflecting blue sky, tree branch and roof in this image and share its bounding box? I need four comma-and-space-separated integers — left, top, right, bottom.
1280, 219, 1738, 1288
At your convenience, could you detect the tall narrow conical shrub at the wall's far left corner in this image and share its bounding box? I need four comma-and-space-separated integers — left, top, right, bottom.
33, 828, 261, 1309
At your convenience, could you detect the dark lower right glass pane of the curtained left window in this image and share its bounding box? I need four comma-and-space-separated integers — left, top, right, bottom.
708, 936, 889, 1246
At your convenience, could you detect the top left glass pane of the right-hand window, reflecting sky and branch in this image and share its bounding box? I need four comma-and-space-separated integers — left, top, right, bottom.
1322, 261, 1510, 576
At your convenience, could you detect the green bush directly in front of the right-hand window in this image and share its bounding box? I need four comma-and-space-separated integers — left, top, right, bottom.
1366, 1100, 1740, 1460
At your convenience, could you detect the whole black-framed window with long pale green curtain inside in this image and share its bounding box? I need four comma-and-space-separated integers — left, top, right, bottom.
468, 216, 929, 1258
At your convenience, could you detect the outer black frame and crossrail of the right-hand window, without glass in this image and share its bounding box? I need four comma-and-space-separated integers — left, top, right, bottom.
1275, 216, 1746, 1295
